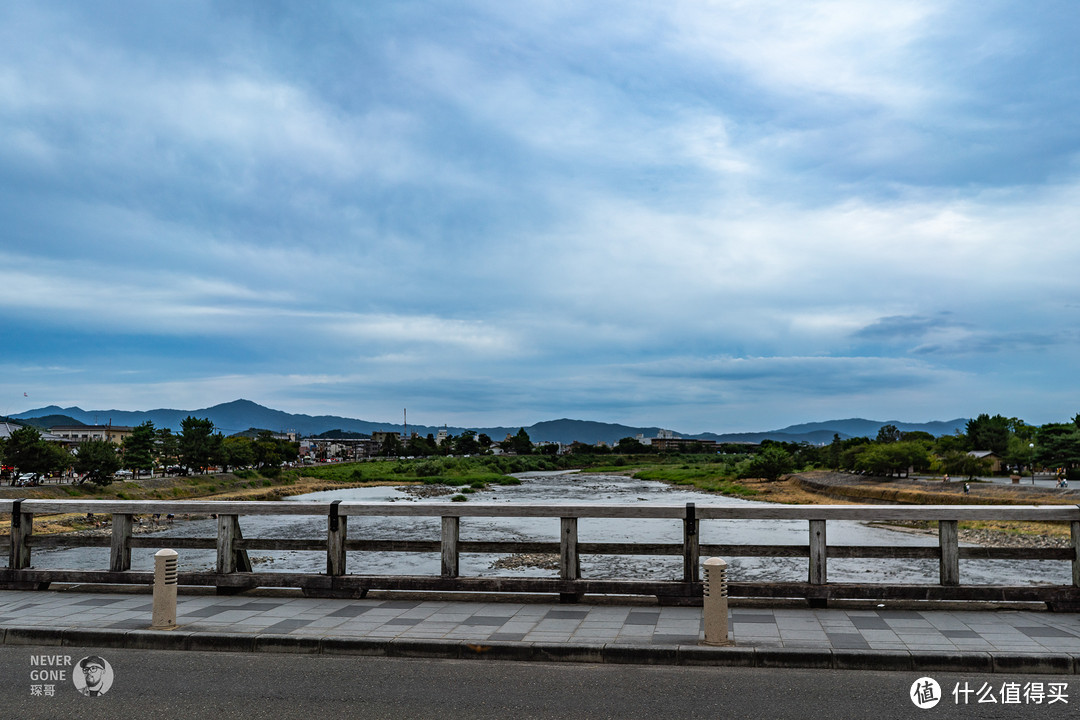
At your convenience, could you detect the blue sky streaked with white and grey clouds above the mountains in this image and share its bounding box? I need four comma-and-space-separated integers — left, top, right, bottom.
0, 0, 1080, 433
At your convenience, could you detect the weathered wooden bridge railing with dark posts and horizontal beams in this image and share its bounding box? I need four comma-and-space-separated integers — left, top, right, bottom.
6, 500, 1080, 609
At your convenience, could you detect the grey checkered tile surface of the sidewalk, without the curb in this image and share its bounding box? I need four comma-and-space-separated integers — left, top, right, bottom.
0, 590, 1080, 655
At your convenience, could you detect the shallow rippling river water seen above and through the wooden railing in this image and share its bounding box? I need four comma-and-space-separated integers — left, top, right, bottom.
27, 473, 1071, 585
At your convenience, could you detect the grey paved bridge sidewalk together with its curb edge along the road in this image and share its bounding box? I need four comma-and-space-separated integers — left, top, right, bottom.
0, 590, 1080, 674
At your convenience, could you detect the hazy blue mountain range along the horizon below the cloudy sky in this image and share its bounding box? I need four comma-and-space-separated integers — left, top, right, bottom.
12, 399, 968, 445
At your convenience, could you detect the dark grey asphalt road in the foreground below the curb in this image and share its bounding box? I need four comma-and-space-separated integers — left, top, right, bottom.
0, 646, 1080, 720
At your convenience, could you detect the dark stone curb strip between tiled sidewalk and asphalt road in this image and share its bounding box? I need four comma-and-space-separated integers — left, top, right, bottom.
0, 626, 1080, 675
